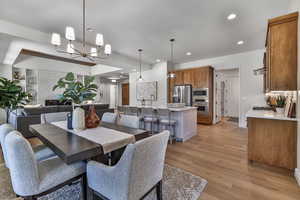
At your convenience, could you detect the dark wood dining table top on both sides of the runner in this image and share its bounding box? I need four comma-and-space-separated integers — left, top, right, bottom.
29, 122, 149, 164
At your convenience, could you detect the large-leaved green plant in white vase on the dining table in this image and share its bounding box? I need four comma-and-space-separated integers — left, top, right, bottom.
53, 72, 98, 130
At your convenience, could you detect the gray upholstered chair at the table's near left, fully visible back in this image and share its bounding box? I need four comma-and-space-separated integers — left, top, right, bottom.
5, 131, 86, 200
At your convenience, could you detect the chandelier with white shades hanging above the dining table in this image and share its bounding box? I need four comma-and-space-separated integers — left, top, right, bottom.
51, 0, 111, 62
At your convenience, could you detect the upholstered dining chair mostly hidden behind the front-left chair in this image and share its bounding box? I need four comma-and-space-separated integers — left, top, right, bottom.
0, 124, 56, 168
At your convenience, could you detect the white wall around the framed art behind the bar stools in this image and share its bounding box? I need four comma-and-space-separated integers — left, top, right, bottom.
129, 62, 168, 106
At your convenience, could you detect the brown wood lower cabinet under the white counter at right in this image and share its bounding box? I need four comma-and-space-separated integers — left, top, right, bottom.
248, 117, 297, 170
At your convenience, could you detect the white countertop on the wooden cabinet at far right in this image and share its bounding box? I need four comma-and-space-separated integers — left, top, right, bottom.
246, 110, 298, 121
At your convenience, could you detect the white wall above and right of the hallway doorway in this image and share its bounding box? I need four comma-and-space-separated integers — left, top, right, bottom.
174, 50, 265, 127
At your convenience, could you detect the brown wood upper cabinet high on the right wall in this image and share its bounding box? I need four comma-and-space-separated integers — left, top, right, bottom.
265, 13, 298, 92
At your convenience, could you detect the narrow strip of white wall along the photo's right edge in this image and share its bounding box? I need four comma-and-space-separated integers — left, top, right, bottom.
290, 0, 300, 185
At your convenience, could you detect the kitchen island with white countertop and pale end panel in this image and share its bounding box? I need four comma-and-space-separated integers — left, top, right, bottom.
128, 106, 197, 142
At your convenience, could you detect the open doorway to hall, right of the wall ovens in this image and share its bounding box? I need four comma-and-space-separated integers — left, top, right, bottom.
215, 69, 240, 123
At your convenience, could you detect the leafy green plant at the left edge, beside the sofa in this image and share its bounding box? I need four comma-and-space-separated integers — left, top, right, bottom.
0, 77, 31, 123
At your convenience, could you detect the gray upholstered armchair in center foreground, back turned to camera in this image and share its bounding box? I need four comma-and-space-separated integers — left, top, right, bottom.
87, 131, 170, 200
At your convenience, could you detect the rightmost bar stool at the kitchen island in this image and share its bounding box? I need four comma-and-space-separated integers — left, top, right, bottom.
157, 108, 177, 144
